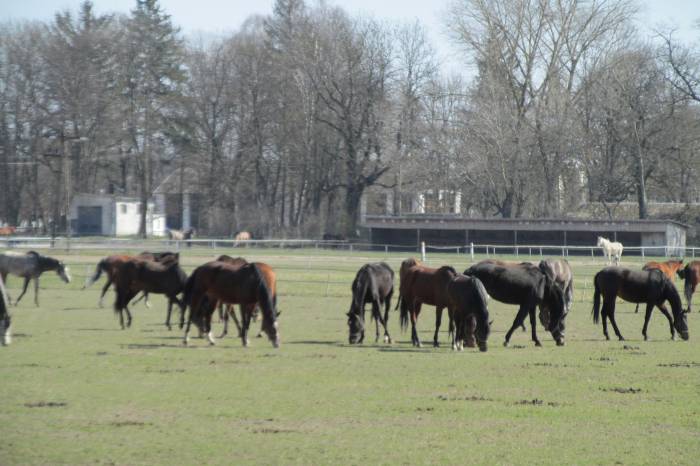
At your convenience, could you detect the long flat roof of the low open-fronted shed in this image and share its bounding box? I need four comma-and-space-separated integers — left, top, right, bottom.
362, 214, 689, 232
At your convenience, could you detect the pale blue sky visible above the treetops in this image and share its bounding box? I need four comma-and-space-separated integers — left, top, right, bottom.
0, 0, 700, 75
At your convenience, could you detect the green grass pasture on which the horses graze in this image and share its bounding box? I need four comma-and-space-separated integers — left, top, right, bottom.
0, 249, 700, 465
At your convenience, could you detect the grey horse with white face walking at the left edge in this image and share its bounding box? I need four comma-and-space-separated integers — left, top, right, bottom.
0, 251, 71, 306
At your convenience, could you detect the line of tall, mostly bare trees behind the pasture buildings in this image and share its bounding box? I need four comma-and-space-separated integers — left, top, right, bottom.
0, 0, 700, 236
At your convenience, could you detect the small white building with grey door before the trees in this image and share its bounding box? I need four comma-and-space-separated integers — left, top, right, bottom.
69, 194, 165, 236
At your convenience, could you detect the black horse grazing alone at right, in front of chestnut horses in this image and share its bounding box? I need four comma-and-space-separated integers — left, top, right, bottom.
593, 267, 688, 341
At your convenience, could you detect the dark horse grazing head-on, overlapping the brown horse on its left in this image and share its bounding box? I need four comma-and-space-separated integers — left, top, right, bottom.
447, 274, 491, 352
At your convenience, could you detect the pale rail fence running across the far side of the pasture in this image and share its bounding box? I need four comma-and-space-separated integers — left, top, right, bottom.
0, 236, 700, 258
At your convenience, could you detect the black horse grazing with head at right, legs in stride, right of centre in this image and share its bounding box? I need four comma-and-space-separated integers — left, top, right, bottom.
464, 260, 566, 346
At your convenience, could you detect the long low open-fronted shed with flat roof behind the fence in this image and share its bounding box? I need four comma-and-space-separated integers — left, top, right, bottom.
362, 214, 688, 254
